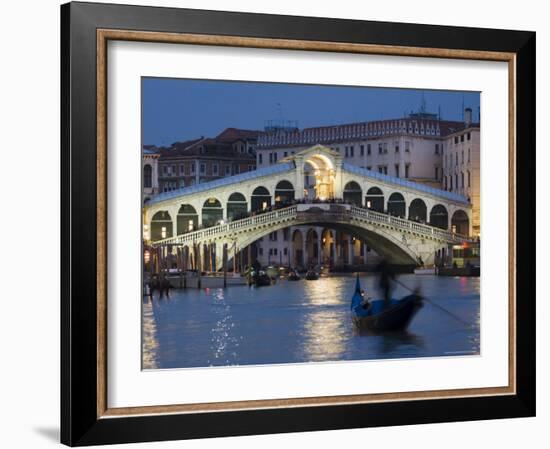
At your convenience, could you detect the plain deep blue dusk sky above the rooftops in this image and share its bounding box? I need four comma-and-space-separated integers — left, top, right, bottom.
142, 78, 480, 146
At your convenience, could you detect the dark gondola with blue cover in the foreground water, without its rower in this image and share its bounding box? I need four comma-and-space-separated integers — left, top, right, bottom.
351, 276, 423, 332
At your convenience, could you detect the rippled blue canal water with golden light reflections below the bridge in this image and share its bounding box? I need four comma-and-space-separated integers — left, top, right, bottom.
142, 274, 480, 369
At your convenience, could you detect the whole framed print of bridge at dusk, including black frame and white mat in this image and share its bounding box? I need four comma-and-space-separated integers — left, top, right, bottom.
61, 3, 535, 445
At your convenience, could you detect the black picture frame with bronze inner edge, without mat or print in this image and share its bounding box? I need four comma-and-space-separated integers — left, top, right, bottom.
61, 2, 536, 446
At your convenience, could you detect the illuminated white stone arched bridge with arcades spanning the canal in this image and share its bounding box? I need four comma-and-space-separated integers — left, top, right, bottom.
143, 145, 472, 270
